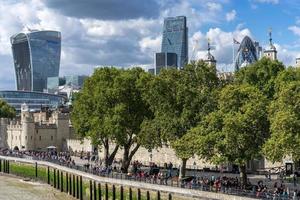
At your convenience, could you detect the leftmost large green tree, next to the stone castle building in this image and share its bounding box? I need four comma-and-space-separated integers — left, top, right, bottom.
71, 68, 121, 166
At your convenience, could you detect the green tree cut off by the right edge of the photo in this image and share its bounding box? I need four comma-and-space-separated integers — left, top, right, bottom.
263, 81, 300, 162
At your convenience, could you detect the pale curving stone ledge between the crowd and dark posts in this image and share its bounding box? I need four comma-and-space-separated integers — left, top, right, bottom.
0, 156, 253, 200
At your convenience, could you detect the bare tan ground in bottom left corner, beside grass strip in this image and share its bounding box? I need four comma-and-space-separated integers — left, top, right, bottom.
0, 174, 72, 200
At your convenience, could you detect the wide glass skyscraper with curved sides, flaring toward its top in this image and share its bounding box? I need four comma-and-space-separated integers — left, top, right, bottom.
10, 30, 61, 92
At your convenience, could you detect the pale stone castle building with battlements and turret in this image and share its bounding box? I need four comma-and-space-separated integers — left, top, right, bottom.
7, 104, 75, 151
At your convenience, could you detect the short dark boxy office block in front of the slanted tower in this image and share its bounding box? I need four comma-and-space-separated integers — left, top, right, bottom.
155, 52, 177, 74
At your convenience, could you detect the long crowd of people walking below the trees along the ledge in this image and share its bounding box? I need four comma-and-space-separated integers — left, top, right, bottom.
0, 149, 300, 199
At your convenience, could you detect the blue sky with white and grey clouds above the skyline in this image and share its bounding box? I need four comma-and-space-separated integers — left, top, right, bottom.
0, 0, 300, 90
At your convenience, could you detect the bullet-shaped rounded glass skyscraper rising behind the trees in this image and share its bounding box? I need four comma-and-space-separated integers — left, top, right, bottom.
235, 36, 258, 71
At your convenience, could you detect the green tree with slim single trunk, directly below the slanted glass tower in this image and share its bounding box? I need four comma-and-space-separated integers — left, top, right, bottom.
144, 62, 219, 177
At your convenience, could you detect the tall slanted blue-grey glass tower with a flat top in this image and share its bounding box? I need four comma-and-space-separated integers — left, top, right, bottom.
161, 16, 188, 68
